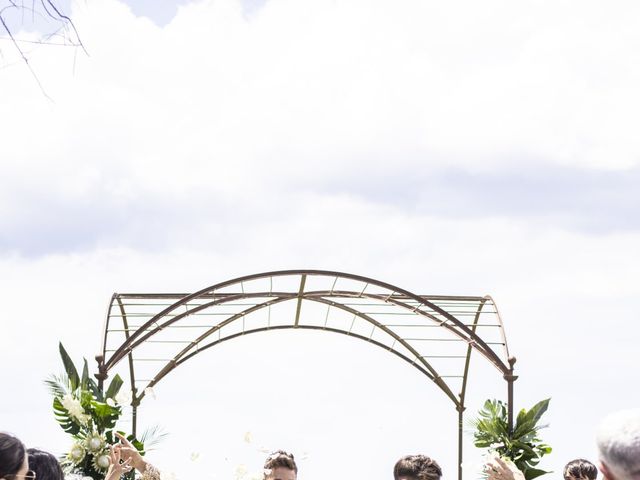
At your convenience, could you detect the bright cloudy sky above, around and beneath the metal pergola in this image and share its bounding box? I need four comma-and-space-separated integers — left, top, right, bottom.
0, 0, 640, 480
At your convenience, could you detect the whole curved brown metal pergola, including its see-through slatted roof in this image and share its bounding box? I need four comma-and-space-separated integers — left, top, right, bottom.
96, 270, 517, 479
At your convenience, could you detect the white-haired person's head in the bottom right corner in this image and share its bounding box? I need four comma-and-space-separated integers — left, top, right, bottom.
596, 409, 640, 480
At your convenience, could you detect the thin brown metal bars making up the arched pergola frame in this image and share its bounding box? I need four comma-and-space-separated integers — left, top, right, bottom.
96, 270, 518, 479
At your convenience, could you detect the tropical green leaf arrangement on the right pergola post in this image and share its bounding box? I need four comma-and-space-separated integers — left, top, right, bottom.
472, 398, 551, 480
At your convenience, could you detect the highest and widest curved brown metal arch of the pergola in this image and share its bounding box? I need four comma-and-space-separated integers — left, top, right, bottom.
105, 270, 509, 374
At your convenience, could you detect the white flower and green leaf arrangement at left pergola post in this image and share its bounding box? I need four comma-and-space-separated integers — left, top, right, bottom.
45, 343, 144, 480
